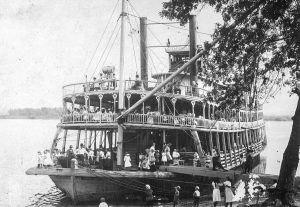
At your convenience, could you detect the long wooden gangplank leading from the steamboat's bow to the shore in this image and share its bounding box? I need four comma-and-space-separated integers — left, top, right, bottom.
159, 165, 292, 184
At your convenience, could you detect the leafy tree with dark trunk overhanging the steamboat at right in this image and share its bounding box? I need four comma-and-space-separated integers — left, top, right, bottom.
160, 0, 300, 205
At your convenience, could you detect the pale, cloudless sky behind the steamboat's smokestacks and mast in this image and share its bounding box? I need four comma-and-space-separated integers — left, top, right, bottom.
0, 0, 297, 115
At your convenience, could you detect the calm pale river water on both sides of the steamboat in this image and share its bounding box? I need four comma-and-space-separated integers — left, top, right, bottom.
0, 119, 300, 207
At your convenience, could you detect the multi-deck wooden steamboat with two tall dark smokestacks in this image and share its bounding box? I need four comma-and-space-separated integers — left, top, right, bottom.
26, 0, 266, 203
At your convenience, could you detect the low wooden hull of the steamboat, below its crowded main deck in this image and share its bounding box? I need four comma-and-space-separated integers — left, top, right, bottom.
26, 154, 260, 204
